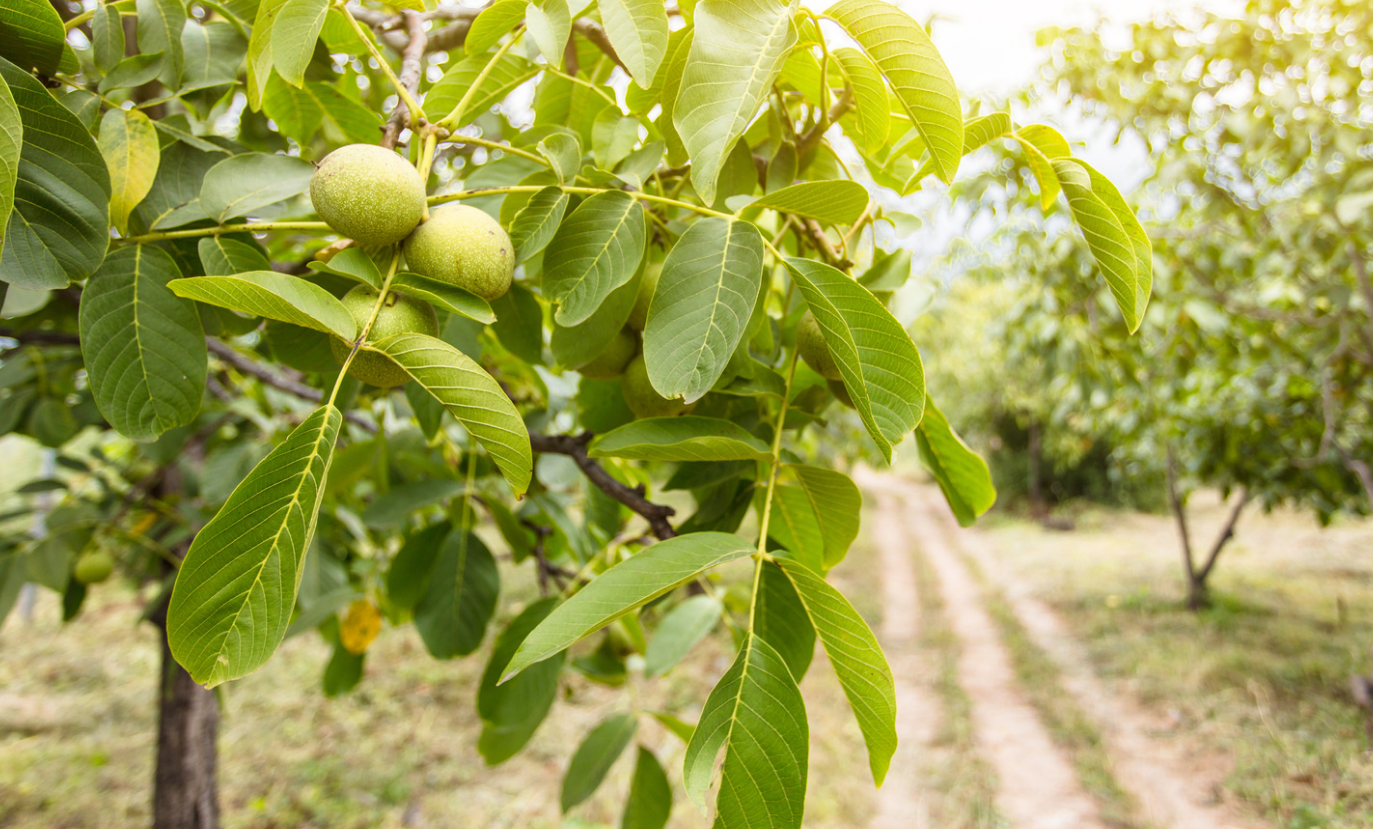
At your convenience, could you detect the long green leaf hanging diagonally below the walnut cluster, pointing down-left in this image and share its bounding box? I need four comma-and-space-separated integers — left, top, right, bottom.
168, 405, 343, 686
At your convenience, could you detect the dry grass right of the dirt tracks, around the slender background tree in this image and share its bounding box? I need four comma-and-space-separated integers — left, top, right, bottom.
989, 497, 1373, 829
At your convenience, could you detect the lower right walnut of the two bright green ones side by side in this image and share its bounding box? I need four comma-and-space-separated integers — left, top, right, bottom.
405, 205, 515, 302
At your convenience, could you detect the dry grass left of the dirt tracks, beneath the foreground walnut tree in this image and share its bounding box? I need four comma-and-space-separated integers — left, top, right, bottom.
0, 551, 872, 829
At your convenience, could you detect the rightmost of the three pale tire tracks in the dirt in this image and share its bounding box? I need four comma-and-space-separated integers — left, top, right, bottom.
939, 484, 1267, 829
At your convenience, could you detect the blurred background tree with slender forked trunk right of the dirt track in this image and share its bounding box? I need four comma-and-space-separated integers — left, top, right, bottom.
936, 0, 1373, 607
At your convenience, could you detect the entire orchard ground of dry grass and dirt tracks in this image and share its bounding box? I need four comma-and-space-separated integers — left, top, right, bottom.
0, 475, 1373, 829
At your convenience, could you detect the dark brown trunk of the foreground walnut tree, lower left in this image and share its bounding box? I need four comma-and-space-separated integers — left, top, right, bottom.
148, 465, 220, 829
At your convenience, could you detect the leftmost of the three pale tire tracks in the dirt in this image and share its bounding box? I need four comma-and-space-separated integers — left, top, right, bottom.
869, 482, 943, 829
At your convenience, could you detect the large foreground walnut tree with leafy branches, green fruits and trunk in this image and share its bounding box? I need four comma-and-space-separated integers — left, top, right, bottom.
0, 0, 1152, 826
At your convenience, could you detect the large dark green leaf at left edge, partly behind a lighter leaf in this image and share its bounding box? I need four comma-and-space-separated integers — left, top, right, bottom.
0, 56, 110, 291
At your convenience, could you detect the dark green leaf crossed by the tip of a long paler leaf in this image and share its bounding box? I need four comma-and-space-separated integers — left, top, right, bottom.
476, 597, 563, 766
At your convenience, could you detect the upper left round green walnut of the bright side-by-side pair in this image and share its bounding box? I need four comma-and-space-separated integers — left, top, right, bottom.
310, 144, 424, 247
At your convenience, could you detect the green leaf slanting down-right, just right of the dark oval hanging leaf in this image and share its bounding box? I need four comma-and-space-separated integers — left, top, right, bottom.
787, 258, 925, 463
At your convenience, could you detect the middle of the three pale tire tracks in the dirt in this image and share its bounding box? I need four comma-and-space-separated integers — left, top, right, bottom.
889, 476, 1103, 829
